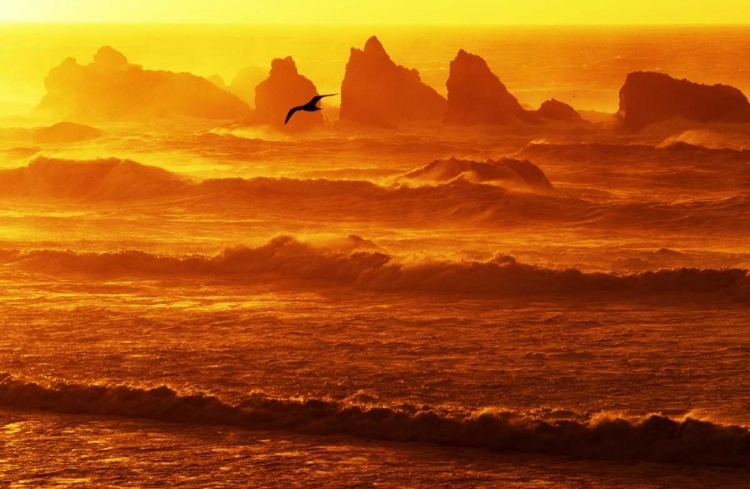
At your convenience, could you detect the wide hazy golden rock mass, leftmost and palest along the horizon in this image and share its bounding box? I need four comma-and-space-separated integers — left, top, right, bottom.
38, 46, 250, 121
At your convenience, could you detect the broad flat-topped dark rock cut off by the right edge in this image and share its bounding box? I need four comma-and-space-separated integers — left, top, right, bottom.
618, 71, 750, 130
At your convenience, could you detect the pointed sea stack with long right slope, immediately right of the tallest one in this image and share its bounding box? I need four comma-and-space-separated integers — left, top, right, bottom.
445, 49, 535, 125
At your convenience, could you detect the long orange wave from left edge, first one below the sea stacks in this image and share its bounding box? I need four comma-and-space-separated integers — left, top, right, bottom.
0, 156, 586, 226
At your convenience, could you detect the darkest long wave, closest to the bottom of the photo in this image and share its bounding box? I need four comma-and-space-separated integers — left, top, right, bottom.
0, 373, 750, 468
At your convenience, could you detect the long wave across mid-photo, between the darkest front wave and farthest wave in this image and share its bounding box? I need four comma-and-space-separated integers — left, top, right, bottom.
0, 236, 750, 301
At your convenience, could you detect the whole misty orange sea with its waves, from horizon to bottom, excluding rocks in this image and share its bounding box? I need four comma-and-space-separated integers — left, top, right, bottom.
0, 25, 750, 488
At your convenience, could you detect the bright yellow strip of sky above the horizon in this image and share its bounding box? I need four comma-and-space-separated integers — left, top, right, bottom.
0, 0, 750, 25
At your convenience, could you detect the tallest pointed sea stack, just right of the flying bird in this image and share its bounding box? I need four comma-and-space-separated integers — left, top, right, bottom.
340, 36, 446, 127
